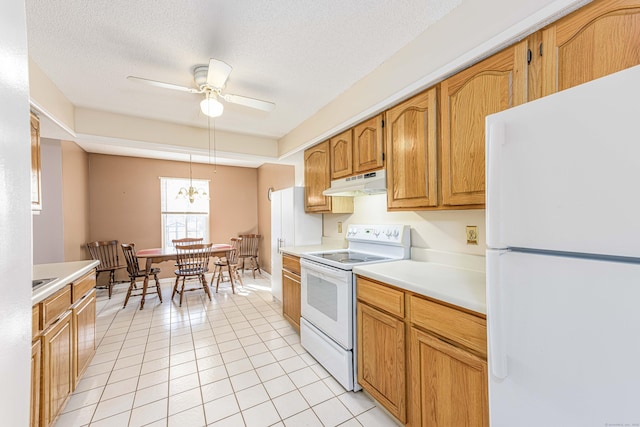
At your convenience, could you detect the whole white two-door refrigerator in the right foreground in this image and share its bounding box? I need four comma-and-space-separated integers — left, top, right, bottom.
486, 67, 640, 427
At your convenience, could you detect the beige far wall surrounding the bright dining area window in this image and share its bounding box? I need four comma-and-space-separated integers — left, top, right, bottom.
89, 154, 258, 279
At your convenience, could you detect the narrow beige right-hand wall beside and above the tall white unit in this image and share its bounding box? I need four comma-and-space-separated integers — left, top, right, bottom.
258, 163, 295, 273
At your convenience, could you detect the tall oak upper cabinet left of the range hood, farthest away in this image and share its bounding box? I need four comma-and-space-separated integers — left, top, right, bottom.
304, 141, 331, 212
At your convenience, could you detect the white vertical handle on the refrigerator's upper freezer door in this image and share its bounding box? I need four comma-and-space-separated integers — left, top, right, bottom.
485, 120, 507, 248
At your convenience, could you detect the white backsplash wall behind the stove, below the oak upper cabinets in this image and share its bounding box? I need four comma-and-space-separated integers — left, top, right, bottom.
323, 194, 486, 255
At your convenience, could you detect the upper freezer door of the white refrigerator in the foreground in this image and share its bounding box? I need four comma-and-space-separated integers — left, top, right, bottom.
487, 66, 640, 257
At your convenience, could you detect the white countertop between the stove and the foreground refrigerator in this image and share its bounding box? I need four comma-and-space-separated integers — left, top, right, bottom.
353, 260, 487, 314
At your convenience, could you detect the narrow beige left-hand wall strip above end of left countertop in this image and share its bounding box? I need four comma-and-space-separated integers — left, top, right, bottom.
61, 141, 89, 261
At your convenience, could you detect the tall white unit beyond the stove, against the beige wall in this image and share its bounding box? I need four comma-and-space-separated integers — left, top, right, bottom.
271, 187, 322, 302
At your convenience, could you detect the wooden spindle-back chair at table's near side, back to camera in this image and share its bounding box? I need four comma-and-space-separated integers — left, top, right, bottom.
171, 243, 213, 307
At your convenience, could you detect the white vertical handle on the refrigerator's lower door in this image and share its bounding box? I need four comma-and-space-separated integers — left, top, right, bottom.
487, 250, 508, 380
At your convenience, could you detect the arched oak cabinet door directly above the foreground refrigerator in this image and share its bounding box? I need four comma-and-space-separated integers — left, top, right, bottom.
542, 0, 640, 95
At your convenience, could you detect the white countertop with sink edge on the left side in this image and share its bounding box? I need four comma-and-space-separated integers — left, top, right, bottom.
31, 260, 100, 305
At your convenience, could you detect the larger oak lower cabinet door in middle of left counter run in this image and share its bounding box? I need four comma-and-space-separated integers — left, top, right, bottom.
42, 310, 73, 426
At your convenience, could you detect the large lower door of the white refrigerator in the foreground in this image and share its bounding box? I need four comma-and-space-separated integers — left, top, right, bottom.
487, 250, 640, 427
